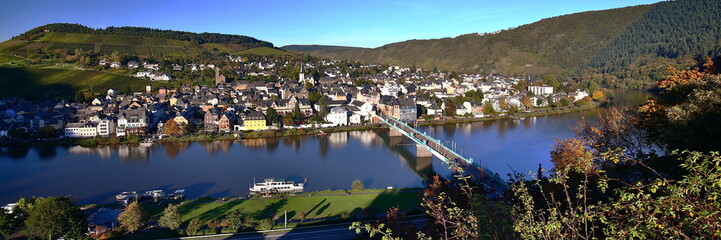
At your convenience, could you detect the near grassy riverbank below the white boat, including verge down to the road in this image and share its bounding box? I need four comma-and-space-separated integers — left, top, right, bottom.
104, 189, 422, 239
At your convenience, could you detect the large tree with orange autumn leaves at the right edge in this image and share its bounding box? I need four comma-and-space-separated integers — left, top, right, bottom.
639, 60, 721, 151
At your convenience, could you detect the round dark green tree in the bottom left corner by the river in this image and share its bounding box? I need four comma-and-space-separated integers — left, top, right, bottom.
25, 197, 88, 239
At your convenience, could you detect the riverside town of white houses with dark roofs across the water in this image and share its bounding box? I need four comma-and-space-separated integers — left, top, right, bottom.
0, 56, 602, 141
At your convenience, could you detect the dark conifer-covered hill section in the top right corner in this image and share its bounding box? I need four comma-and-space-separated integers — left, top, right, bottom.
592, 0, 721, 72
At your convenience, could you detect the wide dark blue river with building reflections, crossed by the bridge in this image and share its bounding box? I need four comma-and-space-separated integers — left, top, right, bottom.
0, 91, 646, 205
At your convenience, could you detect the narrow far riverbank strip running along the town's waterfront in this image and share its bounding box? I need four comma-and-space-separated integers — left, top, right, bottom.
0, 102, 602, 147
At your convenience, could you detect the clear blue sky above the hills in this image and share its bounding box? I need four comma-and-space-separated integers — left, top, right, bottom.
0, 0, 658, 47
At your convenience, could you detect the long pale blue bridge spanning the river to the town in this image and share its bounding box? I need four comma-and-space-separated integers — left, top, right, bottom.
374, 113, 510, 194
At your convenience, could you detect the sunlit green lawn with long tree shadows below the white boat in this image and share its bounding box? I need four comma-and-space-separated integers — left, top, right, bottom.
148, 189, 420, 223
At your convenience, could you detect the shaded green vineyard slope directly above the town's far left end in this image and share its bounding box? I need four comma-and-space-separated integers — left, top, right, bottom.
0, 67, 161, 98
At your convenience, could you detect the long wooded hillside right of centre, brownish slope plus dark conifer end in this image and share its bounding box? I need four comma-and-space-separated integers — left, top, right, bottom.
286, 0, 721, 78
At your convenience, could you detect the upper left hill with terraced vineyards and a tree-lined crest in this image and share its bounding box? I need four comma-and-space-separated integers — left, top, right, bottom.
0, 23, 273, 56
